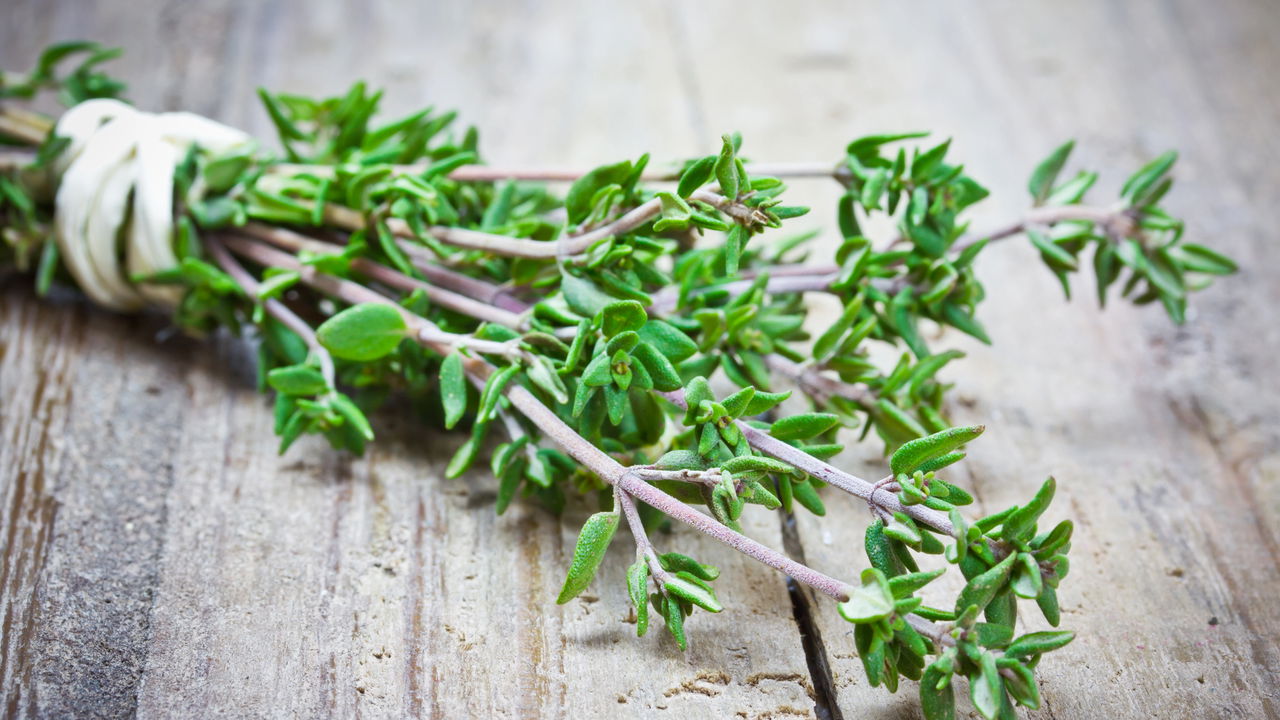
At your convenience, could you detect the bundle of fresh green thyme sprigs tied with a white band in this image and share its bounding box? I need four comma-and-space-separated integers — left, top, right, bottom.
0, 44, 1235, 719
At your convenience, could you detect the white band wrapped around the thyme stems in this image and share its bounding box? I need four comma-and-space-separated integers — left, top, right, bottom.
54, 100, 252, 310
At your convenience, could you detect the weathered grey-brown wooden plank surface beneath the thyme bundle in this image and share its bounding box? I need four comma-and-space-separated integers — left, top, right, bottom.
0, 0, 1280, 717
